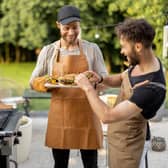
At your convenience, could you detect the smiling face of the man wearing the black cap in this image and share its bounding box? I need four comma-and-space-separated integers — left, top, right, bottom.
58, 22, 80, 44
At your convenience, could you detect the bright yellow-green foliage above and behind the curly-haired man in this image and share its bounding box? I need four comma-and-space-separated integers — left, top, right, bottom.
109, 0, 168, 56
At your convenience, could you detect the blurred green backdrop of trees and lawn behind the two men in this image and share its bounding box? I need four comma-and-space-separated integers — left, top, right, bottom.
0, 0, 168, 108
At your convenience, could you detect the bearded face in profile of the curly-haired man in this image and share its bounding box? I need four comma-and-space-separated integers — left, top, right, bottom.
120, 37, 139, 65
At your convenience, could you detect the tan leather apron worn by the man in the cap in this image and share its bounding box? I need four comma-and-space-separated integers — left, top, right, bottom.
46, 42, 103, 149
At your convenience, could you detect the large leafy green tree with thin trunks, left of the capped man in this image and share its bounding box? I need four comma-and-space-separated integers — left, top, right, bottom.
0, 0, 62, 62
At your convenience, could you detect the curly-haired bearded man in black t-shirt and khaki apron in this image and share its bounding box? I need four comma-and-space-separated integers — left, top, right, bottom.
75, 19, 166, 168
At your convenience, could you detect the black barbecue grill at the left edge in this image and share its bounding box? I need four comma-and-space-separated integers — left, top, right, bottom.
0, 108, 22, 168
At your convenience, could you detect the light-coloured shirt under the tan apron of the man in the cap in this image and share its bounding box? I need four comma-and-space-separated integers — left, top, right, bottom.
30, 40, 108, 81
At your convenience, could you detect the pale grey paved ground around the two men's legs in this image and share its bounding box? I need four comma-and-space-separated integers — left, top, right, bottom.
11, 111, 168, 168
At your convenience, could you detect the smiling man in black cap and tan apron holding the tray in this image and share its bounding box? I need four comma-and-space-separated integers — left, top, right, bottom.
30, 5, 107, 168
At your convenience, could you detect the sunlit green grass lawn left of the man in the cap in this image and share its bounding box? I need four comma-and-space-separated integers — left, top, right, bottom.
0, 62, 49, 110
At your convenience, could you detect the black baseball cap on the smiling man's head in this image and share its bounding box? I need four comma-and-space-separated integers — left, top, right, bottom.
57, 5, 80, 25
